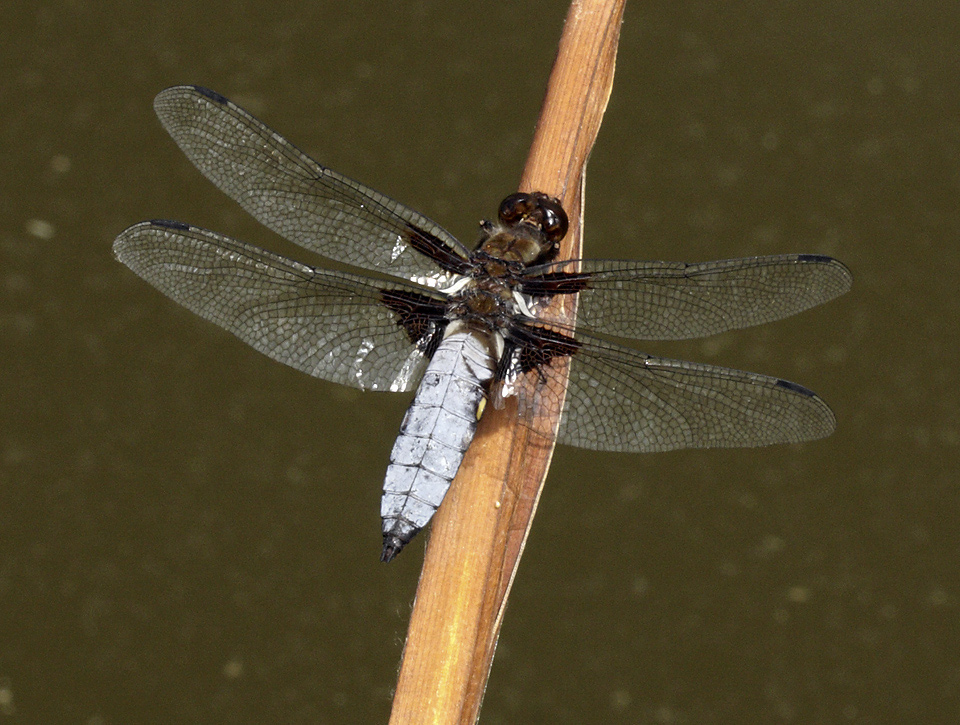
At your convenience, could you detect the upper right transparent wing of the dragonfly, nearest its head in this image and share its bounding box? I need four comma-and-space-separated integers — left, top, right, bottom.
523, 254, 852, 340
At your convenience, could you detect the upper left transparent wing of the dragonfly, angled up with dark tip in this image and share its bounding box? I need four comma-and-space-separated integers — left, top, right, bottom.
153, 86, 469, 286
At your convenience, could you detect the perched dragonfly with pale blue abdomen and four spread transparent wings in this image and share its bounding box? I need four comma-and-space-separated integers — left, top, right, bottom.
113, 86, 851, 561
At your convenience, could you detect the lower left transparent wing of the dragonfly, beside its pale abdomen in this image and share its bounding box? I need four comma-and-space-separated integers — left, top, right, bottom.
113, 221, 440, 391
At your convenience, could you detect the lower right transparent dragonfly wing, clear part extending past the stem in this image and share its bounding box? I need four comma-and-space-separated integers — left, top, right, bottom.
521, 334, 836, 453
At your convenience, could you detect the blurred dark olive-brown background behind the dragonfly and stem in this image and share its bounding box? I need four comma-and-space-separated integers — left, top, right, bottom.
0, 0, 960, 725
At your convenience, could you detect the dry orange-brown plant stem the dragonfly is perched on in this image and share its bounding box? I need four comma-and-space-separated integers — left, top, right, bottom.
390, 0, 625, 725
